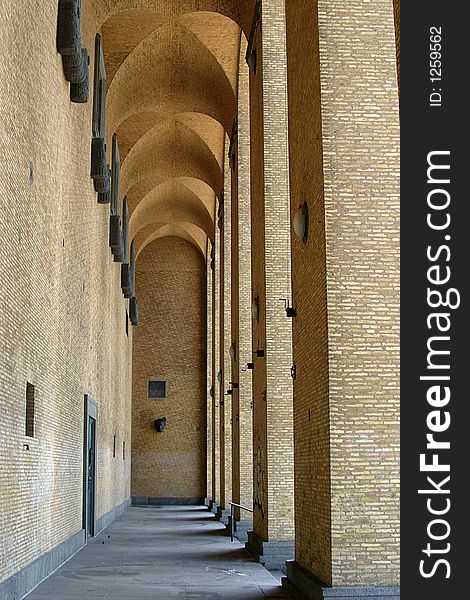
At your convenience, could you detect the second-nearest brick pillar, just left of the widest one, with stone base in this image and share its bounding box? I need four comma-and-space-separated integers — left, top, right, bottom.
248, 0, 294, 568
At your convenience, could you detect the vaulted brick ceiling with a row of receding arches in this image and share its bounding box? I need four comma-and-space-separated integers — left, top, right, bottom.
98, 0, 248, 254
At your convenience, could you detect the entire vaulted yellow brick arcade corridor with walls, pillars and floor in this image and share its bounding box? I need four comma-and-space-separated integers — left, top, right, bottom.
0, 0, 400, 600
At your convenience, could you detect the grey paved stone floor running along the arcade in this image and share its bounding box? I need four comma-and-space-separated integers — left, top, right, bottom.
27, 506, 290, 600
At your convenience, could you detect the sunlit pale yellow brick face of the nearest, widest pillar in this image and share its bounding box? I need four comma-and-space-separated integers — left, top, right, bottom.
318, 0, 400, 584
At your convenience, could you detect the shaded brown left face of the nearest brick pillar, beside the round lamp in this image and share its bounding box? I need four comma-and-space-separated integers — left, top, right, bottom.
286, 0, 331, 583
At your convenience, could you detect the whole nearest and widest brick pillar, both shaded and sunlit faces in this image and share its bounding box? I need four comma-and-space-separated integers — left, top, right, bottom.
285, 0, 399, 599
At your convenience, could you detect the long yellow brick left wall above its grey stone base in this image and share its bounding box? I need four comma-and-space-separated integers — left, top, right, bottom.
0, 0, 132, 580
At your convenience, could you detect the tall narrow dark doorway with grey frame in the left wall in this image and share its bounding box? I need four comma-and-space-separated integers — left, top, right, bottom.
83, 395, 97, 538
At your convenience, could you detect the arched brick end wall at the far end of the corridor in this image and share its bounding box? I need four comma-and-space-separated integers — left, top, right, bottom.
132, 237, 206, 498
